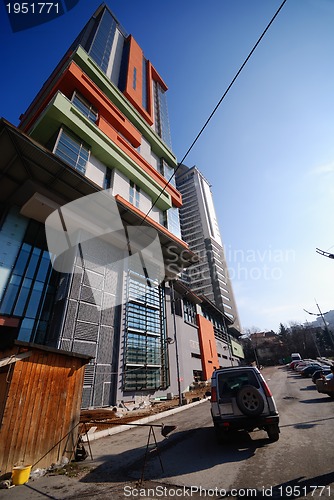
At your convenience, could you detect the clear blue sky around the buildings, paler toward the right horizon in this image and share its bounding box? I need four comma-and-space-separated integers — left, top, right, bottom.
0, 0, 334, 331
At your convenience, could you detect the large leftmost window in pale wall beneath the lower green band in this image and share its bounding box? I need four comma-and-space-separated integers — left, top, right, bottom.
54, 129, 89, 174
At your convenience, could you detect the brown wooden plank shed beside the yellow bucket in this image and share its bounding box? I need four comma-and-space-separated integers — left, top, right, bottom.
0, 340, 90, 475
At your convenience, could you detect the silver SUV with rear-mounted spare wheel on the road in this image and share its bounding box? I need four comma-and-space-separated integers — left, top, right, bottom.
211, 366, 280, 441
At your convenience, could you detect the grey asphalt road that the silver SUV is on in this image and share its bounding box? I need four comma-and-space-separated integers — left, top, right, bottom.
0, 367, 334, 500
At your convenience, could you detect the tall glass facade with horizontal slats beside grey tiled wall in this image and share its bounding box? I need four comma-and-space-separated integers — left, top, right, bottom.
123, 272, 167, 391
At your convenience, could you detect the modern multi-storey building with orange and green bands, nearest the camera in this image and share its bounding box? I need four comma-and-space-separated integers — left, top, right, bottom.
0, 4, 242, 407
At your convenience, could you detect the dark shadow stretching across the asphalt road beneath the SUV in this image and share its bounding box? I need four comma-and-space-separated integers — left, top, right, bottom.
80, 427, 273, 483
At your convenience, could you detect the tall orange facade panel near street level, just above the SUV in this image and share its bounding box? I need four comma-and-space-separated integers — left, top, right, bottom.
197, 314, 219, 380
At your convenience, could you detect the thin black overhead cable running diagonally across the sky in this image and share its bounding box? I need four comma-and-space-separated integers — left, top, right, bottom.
140, 0, 287, 225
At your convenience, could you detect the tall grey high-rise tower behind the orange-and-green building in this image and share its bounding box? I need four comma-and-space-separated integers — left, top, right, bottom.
176, 165, 240, 331
